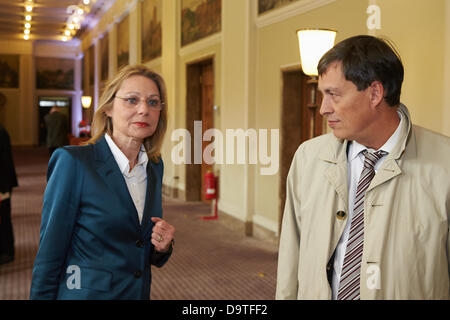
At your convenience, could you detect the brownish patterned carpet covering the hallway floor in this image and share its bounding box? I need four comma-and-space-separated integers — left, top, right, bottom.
0, 147, 277, 300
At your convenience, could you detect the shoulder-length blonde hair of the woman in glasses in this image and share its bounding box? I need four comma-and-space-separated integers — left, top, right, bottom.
87, 65, 167, 163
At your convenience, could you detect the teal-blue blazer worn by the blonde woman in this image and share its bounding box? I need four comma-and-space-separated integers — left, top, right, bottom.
30, 137, 171, 299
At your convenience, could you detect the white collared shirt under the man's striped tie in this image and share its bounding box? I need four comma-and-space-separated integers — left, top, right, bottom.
331, 112, 404, 300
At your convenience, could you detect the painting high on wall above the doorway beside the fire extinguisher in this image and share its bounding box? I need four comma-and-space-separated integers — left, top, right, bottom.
181, 0, 222, 46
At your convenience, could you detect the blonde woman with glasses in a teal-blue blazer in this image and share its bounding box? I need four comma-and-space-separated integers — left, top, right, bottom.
30, 66, 175, 299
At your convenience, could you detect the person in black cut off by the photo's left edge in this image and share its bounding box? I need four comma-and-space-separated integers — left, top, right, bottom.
0, 125, 18, 264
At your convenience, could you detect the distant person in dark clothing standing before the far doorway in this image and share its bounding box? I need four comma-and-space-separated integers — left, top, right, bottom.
44, 107, 69, 156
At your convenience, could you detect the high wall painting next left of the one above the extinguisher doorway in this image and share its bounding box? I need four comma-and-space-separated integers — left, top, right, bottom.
141, 0, 162, 62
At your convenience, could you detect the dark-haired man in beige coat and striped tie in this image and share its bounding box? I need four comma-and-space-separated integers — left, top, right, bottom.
276, 36, 450, 299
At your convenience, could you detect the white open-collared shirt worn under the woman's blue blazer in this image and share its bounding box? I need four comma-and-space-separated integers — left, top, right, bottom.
105, 133, 148, 223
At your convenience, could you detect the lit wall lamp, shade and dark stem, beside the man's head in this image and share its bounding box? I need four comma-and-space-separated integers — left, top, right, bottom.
297, 29, 336, 138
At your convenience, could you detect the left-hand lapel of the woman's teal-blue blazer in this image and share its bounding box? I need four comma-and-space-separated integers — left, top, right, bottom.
94, 137, 140, 230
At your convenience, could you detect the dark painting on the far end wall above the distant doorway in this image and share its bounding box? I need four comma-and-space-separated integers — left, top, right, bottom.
36, 58, 75, 90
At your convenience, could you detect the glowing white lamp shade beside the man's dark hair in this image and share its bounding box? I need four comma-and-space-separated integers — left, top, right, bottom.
297, 29, 336, 76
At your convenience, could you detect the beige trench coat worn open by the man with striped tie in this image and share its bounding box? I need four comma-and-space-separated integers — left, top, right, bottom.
276, 105, 450, 299
